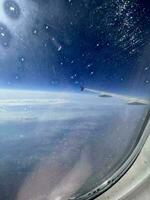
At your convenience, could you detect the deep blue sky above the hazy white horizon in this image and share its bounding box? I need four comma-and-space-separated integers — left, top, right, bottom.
0, 0, 150, 96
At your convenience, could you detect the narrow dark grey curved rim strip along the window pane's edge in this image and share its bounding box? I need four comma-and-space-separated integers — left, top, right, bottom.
73, 108, 150, 200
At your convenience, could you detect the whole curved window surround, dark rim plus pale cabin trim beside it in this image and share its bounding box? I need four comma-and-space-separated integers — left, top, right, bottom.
74, 109, 150, 200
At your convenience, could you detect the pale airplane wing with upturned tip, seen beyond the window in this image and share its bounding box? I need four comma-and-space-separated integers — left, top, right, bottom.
81, 86, 150, 105
